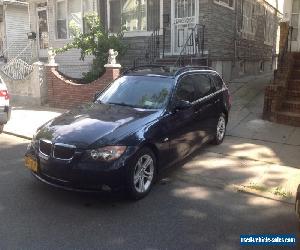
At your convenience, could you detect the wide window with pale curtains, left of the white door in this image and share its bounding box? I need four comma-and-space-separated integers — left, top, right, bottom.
108, 0, 160, 33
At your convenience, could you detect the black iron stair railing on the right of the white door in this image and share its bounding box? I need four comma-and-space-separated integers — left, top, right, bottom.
174, 24, 205, 67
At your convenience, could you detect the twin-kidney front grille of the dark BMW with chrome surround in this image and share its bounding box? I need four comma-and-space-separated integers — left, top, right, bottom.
39, 140, 76, 160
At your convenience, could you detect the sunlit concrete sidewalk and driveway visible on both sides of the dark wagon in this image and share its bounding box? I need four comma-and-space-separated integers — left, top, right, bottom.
4, 72, 300, 203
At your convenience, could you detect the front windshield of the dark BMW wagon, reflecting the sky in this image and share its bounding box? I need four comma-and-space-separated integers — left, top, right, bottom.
97, 76, 173, 109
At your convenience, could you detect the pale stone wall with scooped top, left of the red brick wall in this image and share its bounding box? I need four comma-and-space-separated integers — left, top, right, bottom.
0, 62, 47, 106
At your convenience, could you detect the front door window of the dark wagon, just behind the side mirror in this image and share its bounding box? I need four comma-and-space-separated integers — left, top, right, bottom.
176, 75, 197, 102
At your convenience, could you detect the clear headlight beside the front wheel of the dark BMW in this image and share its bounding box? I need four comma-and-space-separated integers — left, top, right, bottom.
87, 146, 127, 161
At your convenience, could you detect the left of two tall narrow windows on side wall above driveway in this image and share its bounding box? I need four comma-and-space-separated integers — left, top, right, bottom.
241, 0, 256, 35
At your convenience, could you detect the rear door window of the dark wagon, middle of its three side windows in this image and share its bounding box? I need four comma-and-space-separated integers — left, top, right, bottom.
193, 74, 215, 99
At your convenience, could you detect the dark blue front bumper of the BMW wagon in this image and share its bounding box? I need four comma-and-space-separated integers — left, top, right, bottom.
25, 143, 137, 192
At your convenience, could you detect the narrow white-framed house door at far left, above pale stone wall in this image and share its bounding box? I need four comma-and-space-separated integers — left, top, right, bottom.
37, 7, 49, 58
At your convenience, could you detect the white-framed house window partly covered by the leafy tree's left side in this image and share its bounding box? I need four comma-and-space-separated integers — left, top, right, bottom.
55, 0, 96, 39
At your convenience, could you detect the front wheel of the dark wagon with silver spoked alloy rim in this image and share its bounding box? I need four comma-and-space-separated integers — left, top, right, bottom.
126, 148, 157, 200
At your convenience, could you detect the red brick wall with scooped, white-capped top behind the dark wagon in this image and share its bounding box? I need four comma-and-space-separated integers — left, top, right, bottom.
46, 65, 120, 109
